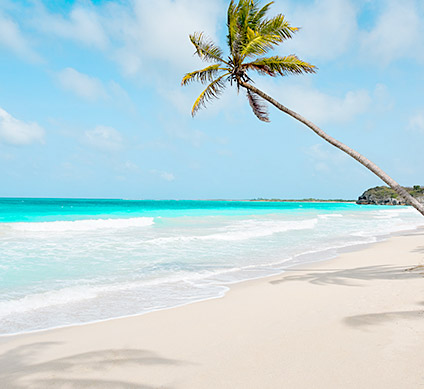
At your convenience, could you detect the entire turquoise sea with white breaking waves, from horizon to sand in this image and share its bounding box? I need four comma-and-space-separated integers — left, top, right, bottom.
0, 199, 424, 334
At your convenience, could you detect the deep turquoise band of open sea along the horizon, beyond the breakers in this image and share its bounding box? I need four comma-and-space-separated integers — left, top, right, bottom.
0, 198, 358, 223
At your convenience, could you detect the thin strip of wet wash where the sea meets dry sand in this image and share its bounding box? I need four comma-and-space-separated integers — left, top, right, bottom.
0, 225, 424, 336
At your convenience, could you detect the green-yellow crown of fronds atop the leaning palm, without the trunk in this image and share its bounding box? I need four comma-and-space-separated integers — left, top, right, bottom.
181, 0, 316, 118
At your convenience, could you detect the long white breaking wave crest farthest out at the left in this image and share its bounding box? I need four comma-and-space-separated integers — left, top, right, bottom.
9, 217, 154, 232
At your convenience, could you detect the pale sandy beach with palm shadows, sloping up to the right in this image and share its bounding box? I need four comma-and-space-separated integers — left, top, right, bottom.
0, 230, 424, 389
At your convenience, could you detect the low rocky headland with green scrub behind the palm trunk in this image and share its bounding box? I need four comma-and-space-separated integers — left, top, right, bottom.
356, 185, 424, 205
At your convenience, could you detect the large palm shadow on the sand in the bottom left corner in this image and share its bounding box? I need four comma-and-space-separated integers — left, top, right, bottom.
0, 342, 188, 389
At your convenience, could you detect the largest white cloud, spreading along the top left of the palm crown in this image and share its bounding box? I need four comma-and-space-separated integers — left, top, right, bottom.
30, 0, 225, 77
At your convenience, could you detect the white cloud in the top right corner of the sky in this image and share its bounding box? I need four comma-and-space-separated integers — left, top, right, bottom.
361, 0, 424, 65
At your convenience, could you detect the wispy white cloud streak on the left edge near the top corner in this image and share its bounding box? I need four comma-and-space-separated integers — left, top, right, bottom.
0, 13, 41, 62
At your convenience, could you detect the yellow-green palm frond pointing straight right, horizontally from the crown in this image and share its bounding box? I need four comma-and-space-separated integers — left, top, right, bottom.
243, 54, 316, 77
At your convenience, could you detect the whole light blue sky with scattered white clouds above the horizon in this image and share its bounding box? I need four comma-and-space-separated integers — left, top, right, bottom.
0, 0, 424, 199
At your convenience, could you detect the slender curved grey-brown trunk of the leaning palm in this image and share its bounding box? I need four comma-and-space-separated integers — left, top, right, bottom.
239, 80, 424, 216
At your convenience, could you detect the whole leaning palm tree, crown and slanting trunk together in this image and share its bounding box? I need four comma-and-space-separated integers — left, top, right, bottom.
181, 0, 424, 216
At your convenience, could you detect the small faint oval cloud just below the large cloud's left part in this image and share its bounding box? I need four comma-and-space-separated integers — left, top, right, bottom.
57, 68, 107, 101
